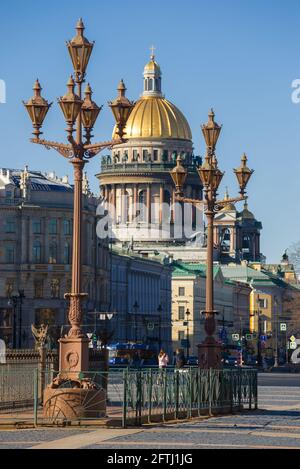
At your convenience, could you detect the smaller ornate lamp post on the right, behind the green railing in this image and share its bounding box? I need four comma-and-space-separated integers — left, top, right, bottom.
171, 110, 253, 368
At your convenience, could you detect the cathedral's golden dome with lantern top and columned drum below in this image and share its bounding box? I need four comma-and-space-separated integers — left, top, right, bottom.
97, 55, 202, 258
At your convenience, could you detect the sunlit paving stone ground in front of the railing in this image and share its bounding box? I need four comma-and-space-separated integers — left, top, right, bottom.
0, 376, 300, 452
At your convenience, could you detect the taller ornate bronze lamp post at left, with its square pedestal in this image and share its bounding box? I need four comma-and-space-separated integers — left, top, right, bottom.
24, 19, 134, 418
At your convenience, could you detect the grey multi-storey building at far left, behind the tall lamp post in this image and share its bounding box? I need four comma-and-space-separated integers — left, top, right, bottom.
0, 167, 110, 347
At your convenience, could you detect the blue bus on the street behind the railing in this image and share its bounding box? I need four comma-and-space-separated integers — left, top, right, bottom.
107, 342, 158, 367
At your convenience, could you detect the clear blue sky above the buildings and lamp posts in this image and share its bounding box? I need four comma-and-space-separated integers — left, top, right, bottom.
0, 0, 300, 262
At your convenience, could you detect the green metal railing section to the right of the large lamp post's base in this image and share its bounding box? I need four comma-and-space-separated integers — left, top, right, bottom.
123, 368, 257, 425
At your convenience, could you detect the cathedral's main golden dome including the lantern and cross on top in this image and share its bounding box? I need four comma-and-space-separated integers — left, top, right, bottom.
113, 54, 192, 141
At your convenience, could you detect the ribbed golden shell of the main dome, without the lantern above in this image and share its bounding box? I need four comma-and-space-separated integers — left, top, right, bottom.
113, 96, 192, 140
